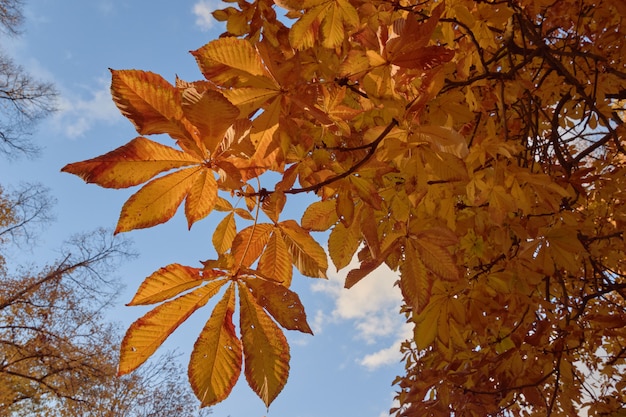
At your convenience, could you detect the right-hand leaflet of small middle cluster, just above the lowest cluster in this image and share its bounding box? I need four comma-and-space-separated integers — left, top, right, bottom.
278, 220, 328, 278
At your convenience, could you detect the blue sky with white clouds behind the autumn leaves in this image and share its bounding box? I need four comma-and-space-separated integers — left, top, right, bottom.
0, 0, 408, 417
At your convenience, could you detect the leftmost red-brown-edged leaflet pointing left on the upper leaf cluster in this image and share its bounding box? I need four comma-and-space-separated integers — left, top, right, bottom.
61, 137, 202, 188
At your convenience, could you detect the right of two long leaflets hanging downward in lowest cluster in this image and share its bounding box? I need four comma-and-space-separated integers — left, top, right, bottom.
238, 284, 290, 407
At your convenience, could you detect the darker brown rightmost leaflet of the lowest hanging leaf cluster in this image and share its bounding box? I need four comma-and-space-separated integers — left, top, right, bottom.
245, 278, 313, 334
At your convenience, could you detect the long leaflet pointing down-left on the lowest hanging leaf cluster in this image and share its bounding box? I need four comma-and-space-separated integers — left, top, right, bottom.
118, 280, 227, 375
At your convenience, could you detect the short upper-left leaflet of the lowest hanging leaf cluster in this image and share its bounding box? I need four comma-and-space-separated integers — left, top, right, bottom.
127, 264, 203, 306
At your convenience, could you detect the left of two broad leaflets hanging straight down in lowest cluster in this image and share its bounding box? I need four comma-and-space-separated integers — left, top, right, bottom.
189, 284, 242, 406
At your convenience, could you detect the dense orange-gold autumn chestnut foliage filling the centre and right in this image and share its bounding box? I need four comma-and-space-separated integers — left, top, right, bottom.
63, 0, 626, 416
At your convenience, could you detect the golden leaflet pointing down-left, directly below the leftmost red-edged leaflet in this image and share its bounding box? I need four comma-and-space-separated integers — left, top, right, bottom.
115, 167, 203, 233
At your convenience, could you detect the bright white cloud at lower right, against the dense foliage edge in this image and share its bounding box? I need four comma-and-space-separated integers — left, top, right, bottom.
312, 262, 411, 369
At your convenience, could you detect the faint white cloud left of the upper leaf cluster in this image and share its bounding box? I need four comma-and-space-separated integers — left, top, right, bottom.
52, 79, 121, 138
